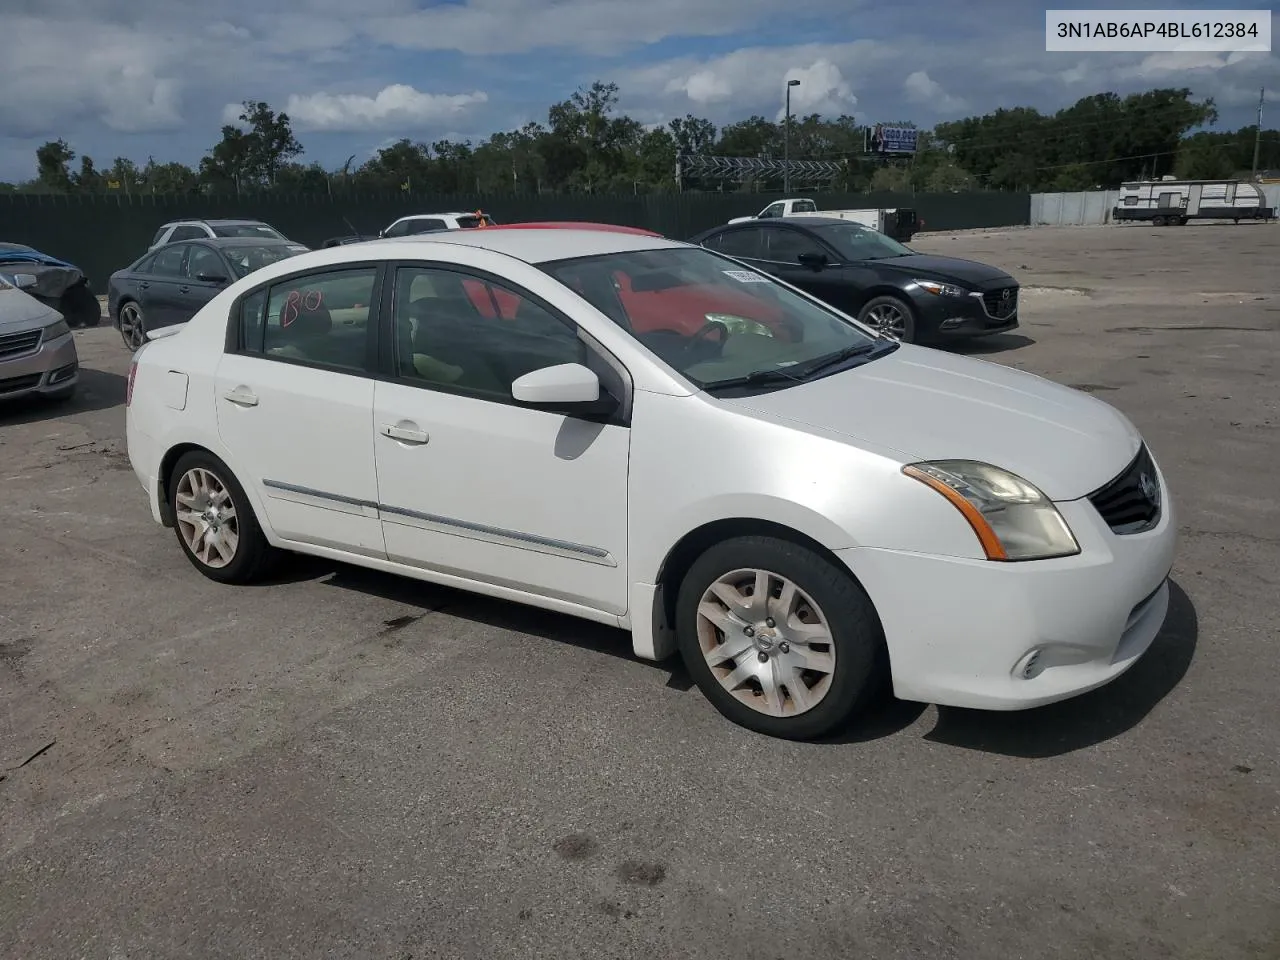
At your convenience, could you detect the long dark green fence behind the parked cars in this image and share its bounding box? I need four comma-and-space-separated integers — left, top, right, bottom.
0, 191, 1030, 291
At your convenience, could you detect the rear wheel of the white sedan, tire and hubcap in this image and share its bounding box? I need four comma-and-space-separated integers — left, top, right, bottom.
169, 451, 275, 584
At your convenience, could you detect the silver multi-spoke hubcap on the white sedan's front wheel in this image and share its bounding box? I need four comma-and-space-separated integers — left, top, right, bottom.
698, 570, 836, 717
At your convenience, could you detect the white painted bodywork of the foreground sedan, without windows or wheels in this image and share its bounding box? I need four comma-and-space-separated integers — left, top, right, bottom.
127, 230, 1176, 727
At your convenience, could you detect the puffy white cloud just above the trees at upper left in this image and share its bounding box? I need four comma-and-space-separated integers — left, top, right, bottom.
284, 83, 489, 132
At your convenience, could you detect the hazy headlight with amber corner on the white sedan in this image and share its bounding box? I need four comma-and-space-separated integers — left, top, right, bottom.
902, 460, 1080, 561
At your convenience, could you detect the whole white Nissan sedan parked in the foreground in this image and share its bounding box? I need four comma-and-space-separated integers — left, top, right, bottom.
128, 228, 1176, 739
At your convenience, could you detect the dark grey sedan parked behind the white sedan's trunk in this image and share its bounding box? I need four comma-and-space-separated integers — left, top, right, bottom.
106, 237, 307, 349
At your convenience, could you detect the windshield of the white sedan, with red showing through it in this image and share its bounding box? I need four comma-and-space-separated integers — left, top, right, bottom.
543, 248, 892, 389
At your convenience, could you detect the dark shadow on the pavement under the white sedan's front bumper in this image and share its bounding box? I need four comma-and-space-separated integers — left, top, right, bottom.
924, 581, 1199, 759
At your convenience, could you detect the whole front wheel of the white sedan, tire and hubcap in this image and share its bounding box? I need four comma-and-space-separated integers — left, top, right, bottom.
676, 536, 884, 740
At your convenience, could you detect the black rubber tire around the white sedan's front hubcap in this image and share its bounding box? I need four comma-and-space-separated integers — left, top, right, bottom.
676, 536, 887, 740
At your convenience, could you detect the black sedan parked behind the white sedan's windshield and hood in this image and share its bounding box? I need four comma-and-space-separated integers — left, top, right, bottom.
690, 216, 1018, 343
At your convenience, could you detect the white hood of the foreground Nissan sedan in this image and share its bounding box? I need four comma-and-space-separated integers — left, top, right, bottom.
722, 344, 1142, 500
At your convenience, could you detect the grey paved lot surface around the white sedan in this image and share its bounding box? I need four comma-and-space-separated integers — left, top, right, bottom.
0, 224, 1280, 960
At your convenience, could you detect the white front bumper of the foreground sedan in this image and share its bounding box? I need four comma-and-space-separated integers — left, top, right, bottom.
838, 477, 1178, 710
